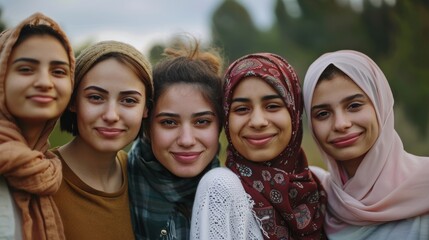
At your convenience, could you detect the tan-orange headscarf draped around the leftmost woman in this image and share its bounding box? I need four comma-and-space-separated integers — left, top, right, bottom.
0, 13, 75, 239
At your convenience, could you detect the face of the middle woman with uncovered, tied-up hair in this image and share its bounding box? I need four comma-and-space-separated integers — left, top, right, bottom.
150, 84, 219, 178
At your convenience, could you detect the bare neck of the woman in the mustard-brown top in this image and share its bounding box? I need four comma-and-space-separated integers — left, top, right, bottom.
59, 136, 123, 193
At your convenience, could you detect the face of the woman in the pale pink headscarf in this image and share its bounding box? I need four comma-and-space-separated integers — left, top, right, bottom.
311, 74, 379, 176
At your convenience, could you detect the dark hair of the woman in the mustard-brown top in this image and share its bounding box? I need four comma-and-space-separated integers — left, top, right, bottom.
60, 52, 152, 136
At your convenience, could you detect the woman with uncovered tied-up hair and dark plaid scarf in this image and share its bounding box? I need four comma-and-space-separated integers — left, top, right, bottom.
128, 38, 222, 240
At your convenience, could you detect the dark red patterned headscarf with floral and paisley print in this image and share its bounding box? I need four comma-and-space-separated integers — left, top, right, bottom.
224, 53, 326, 239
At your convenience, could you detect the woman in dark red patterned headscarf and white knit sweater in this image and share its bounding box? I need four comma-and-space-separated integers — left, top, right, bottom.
191, 53, 326, 239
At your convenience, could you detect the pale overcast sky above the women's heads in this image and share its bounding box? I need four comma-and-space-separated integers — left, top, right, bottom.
0, 0, 274, 53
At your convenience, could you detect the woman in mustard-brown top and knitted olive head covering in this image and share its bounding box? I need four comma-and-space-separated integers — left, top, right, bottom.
54, 41, 153, 239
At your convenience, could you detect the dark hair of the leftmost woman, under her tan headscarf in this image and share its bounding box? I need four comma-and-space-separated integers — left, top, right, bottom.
13, 24, 71, 58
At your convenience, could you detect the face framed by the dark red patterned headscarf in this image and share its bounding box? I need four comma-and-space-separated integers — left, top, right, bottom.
229, 77, 292, 162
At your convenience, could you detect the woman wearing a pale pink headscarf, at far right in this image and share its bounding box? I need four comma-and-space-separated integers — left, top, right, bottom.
304, 50, 429, 239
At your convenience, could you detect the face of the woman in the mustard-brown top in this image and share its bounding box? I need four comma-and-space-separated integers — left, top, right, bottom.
71, 58, 147, 152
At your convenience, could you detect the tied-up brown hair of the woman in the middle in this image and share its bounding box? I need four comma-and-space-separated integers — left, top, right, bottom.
143, 36, 224, 140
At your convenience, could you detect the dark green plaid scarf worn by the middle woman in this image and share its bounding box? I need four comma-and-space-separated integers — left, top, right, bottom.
128, 139, 219, 240
